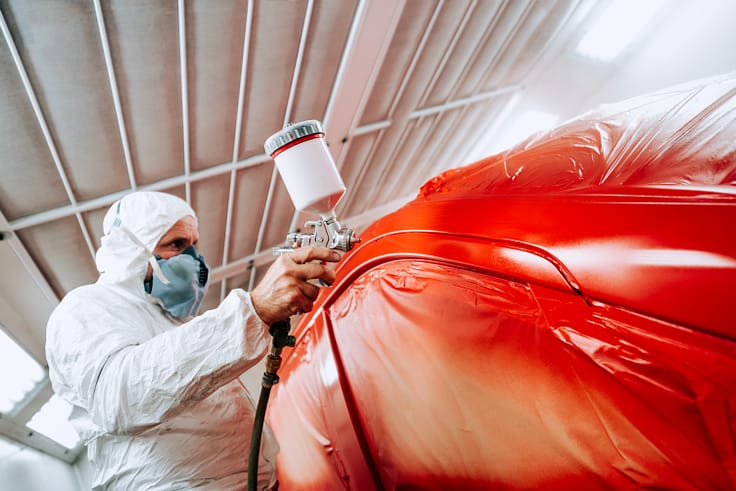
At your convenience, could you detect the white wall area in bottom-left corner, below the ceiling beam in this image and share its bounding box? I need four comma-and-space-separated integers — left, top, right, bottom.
0, 439, 89, 491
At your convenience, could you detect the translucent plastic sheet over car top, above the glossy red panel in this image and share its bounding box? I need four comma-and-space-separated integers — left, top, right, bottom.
421, 72, 736, 197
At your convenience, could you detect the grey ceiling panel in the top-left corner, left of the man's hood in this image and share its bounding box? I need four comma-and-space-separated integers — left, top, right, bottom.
3, 1, 130, 200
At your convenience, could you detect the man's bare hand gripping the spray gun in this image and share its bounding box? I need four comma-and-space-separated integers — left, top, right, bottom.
250, 247, 342, 325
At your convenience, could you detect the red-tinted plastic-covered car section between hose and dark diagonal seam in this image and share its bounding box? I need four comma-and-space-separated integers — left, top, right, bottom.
268, 316, 372, 491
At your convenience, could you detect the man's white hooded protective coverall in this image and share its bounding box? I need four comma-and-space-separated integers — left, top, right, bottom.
46, 192, 278, 491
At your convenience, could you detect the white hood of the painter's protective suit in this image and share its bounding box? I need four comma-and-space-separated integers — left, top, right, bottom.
95, 191, 196, 291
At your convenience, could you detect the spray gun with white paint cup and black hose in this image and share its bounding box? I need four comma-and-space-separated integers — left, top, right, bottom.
248, 120, 360, 490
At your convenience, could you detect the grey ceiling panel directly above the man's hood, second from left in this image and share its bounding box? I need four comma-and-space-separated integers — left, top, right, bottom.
98, 0, 184, 186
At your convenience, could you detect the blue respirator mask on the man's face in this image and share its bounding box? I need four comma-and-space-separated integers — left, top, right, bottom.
144, 246, 210, 319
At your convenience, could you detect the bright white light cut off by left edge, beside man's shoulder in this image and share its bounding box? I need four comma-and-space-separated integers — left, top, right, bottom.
0, 329, 46, 413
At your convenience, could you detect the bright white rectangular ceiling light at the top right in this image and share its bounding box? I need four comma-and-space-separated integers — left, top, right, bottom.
576, 0, 663, 61
